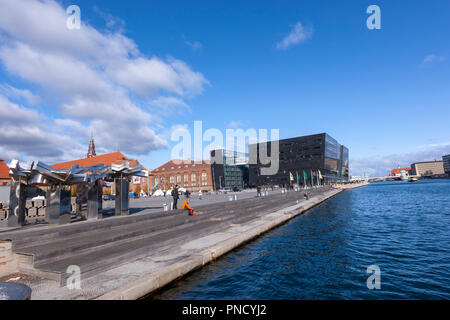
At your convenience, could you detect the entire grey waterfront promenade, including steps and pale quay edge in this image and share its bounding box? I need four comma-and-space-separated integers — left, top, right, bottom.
0, 185, 366, 299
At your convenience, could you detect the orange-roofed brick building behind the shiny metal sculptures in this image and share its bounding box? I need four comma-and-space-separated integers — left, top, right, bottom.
52, 152, 148, 193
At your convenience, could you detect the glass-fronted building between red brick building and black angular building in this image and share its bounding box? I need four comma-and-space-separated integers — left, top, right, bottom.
211, 149, 248, 190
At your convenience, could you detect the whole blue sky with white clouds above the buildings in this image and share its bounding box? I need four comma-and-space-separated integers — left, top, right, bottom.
0, 0, 450, 175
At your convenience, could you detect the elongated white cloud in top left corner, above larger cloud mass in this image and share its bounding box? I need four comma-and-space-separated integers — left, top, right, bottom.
0, 0, 139, 62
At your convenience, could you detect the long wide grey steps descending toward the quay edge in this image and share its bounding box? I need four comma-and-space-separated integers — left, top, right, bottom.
0, 189, 323, 285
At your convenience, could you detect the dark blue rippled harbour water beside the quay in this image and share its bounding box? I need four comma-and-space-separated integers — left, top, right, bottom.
155, 180, 450, 299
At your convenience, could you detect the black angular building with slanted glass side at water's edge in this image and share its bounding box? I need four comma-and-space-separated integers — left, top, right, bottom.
249, 133, 349, 187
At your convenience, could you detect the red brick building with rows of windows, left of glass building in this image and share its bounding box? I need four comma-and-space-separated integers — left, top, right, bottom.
150, 160, 213, 191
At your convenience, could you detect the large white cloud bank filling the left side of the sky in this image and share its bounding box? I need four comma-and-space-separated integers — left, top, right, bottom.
0, 0, 209, 160
